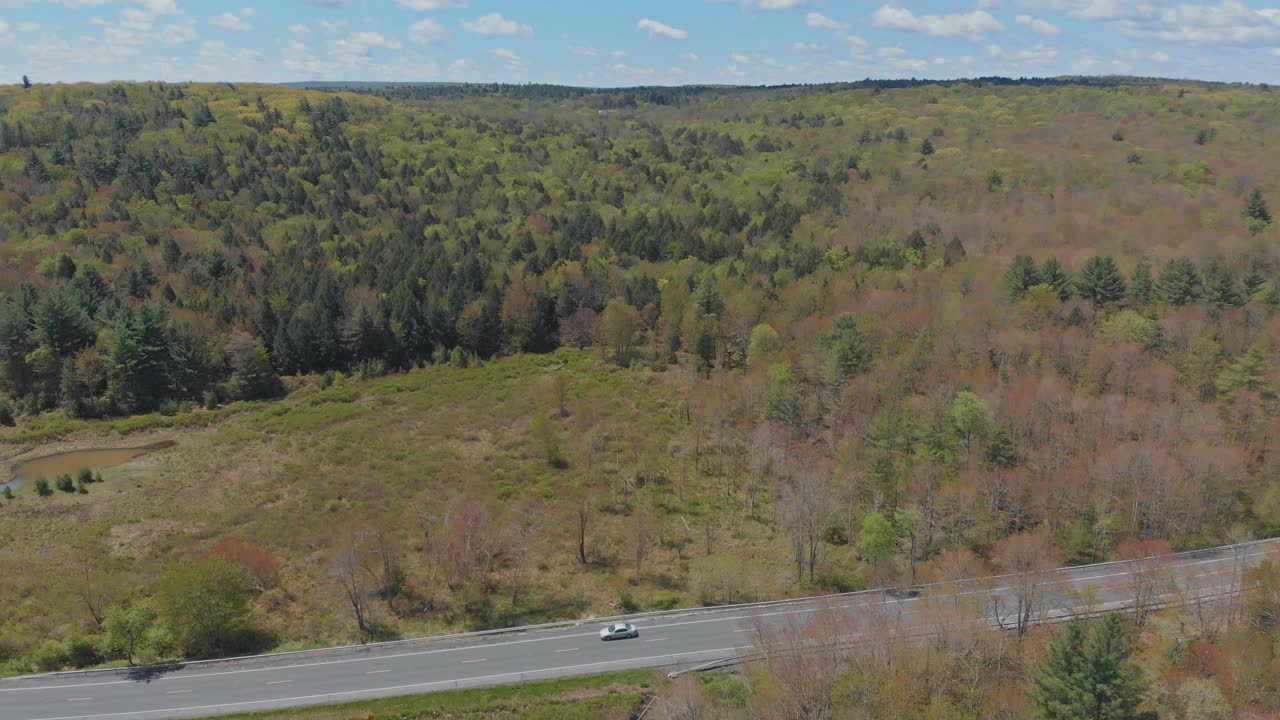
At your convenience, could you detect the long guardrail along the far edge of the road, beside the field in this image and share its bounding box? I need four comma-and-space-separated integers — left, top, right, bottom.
0, 538, 1280, 682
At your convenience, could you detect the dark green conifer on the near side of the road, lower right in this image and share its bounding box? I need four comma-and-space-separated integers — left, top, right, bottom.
1030, 615, 1147, 720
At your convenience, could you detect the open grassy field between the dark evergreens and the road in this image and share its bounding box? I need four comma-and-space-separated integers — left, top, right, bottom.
0, 350, 808, 653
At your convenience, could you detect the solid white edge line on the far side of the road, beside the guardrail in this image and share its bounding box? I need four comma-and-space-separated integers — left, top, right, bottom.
0, 550, 1270, 693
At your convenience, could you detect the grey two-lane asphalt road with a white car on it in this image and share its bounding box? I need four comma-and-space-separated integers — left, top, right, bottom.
0, 541, 1280, 720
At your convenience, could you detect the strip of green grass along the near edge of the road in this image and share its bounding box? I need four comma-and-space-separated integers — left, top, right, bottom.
186, 670, 666, 720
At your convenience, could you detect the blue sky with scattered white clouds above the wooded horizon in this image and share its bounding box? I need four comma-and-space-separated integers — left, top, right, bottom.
0, 0, 1280, 87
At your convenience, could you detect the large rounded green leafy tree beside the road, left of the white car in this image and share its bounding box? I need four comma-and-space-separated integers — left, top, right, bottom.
156, 556, 252, 657
